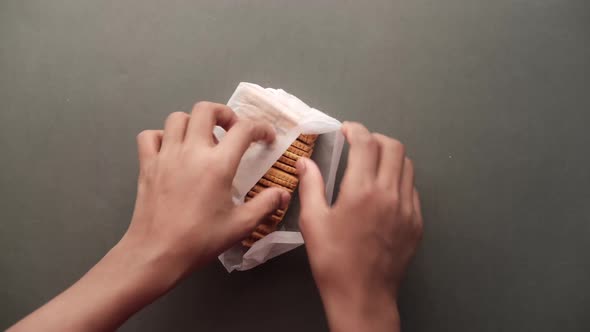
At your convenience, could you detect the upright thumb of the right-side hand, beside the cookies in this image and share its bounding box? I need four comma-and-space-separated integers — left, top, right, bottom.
296, 158, 329, 237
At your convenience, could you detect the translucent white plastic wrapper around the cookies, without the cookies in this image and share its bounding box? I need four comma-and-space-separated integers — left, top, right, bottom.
220, 83, 344, 272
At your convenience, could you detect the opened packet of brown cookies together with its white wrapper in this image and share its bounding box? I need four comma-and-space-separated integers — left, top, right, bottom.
214, 82, 344, 272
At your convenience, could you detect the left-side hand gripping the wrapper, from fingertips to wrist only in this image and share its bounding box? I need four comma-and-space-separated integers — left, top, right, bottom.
122, 102, 290, 279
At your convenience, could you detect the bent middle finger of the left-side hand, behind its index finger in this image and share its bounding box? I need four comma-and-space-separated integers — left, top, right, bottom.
186, 101, 238, 146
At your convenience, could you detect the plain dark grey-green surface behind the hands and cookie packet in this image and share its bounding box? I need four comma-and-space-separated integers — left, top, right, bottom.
0, 0, 590, 332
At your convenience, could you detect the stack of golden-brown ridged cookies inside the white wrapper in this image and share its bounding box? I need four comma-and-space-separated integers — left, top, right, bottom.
242, 135, 317, 247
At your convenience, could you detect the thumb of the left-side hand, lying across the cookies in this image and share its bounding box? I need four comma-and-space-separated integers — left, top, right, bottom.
230, 188, 291, 240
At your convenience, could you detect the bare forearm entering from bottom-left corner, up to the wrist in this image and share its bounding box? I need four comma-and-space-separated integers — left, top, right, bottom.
9, 237, 175, 331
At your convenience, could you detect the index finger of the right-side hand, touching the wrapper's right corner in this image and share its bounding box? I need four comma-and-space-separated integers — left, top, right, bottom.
342, 122, 379, 185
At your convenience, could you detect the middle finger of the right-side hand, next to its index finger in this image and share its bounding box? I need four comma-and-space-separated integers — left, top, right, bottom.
373, 134, 405, 189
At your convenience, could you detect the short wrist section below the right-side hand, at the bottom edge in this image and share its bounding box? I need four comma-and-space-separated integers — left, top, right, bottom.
320, 290, 400, 332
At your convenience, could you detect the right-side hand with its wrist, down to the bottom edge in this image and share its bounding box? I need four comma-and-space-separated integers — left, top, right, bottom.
297, 123, 422, 331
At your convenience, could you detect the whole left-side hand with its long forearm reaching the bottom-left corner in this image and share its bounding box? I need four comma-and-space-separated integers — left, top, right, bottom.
9, 103, 290, 331
